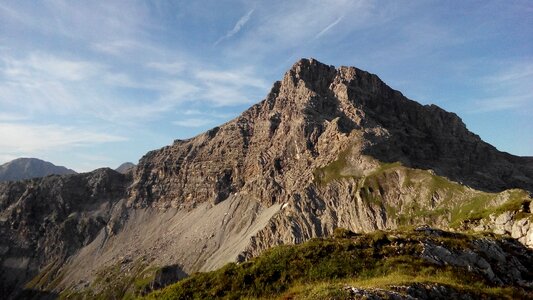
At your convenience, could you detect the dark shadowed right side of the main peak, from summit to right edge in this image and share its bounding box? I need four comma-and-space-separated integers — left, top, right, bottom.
288, 59, 533, 193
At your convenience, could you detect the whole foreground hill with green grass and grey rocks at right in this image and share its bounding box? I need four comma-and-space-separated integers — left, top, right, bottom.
138, 227, 533, 299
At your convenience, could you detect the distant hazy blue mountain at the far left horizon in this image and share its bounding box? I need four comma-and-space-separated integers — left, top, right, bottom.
0, 158, 76, 181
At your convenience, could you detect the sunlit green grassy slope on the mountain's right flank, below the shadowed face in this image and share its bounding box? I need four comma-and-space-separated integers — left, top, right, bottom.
314, 150, 532, 227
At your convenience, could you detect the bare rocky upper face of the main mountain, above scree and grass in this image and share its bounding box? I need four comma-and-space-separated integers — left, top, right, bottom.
130, 59, 533, 207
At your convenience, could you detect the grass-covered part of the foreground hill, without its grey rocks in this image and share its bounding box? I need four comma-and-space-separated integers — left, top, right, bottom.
141, 230, 524, 299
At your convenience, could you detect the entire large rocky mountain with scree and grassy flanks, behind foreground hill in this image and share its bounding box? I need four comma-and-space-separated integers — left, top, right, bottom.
0, 59, 533, 297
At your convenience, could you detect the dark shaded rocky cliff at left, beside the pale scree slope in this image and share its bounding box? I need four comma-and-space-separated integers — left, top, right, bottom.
0, 169, 129, 295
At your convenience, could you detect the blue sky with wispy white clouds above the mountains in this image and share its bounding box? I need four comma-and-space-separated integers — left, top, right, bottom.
0, 0, 533, 171
